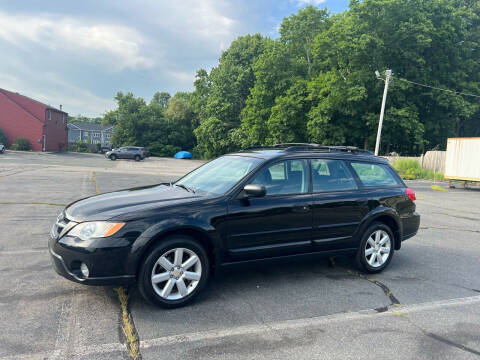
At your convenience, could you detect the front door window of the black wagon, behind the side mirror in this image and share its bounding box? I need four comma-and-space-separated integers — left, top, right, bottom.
251, 160, 308, 195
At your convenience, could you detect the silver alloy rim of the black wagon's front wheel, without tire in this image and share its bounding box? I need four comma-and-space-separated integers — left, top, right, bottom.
151, 248, 202, 300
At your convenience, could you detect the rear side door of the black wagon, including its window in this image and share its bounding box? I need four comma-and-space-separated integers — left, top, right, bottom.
311, 159, 368, 251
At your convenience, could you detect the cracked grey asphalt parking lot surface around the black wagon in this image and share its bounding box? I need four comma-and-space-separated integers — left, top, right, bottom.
0, 152, 480, 359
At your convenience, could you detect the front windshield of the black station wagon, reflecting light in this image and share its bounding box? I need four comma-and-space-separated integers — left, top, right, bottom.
175, 155, 263, 195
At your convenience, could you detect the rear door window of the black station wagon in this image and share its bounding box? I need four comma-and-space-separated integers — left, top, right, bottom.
312, 159, 357, 192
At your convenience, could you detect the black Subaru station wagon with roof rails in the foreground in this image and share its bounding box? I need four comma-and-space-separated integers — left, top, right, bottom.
49, 144, 420, 307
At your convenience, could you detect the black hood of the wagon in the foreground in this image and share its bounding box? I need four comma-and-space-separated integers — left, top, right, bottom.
65, 184, 203, 222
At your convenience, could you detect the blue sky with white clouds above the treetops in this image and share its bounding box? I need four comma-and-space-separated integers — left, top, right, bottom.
0, 0, 349, 117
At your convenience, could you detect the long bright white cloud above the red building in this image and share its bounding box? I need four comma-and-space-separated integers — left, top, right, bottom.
0, 11, 153, 70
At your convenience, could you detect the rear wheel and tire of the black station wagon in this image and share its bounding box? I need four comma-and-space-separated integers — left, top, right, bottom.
355, 222, 395, 274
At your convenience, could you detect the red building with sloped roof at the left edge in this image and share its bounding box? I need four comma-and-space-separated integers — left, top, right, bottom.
0, 88, 68, 151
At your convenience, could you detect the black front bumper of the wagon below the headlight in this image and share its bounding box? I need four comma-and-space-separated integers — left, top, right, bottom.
48, 239, 136, 285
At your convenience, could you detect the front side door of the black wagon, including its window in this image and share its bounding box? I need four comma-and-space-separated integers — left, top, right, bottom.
227, 159, 312, 260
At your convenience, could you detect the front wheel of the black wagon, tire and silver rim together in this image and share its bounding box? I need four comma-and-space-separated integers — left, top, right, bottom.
138, 235, 210, 308
